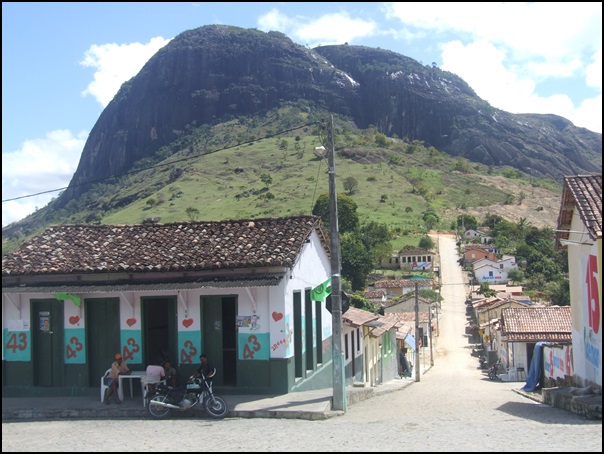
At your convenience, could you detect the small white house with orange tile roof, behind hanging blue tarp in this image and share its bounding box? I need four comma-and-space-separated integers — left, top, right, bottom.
497, 306, 574, 381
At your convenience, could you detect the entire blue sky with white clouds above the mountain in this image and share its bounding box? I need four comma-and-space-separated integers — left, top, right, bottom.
2, 2, 602, 227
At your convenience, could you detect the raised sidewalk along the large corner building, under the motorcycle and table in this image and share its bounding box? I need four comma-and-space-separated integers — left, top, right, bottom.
2, 378, 414, 423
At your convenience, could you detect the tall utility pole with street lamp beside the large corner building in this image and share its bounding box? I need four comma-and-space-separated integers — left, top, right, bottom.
328, 114, 346, 411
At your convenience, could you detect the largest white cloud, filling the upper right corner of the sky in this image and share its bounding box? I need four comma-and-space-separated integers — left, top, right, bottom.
387, 2, 602, 133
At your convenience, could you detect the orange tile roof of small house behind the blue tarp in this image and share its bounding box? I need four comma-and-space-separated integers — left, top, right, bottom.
501, 306, 572, 342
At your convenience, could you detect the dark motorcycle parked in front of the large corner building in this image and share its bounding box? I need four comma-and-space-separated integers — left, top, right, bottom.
146, 369, 228, 419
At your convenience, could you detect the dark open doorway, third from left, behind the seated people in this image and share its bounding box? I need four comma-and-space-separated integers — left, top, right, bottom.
141, 296, 178, 367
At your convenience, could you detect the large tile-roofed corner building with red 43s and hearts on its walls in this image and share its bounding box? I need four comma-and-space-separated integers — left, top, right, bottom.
2, 216, 332, 396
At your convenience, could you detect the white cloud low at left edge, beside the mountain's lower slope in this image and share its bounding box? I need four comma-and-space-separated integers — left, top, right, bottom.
2, 130, 87, 227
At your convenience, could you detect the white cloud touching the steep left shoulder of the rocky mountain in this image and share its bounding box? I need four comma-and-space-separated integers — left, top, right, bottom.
81, 36, 170, 107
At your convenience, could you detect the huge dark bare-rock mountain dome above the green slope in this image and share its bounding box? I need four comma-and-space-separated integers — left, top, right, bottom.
57, 25, 602, 206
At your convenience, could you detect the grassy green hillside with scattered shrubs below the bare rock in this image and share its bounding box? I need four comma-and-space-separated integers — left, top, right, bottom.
3, 106, 561, 253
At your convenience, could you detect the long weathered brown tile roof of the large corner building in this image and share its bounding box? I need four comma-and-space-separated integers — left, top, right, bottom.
2, 216, 329, 277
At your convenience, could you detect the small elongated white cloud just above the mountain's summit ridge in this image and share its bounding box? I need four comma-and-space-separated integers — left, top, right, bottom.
258, 9, 377, 47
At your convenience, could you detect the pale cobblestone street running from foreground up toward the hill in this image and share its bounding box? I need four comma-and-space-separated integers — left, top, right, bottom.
2, 235, 602, 452
